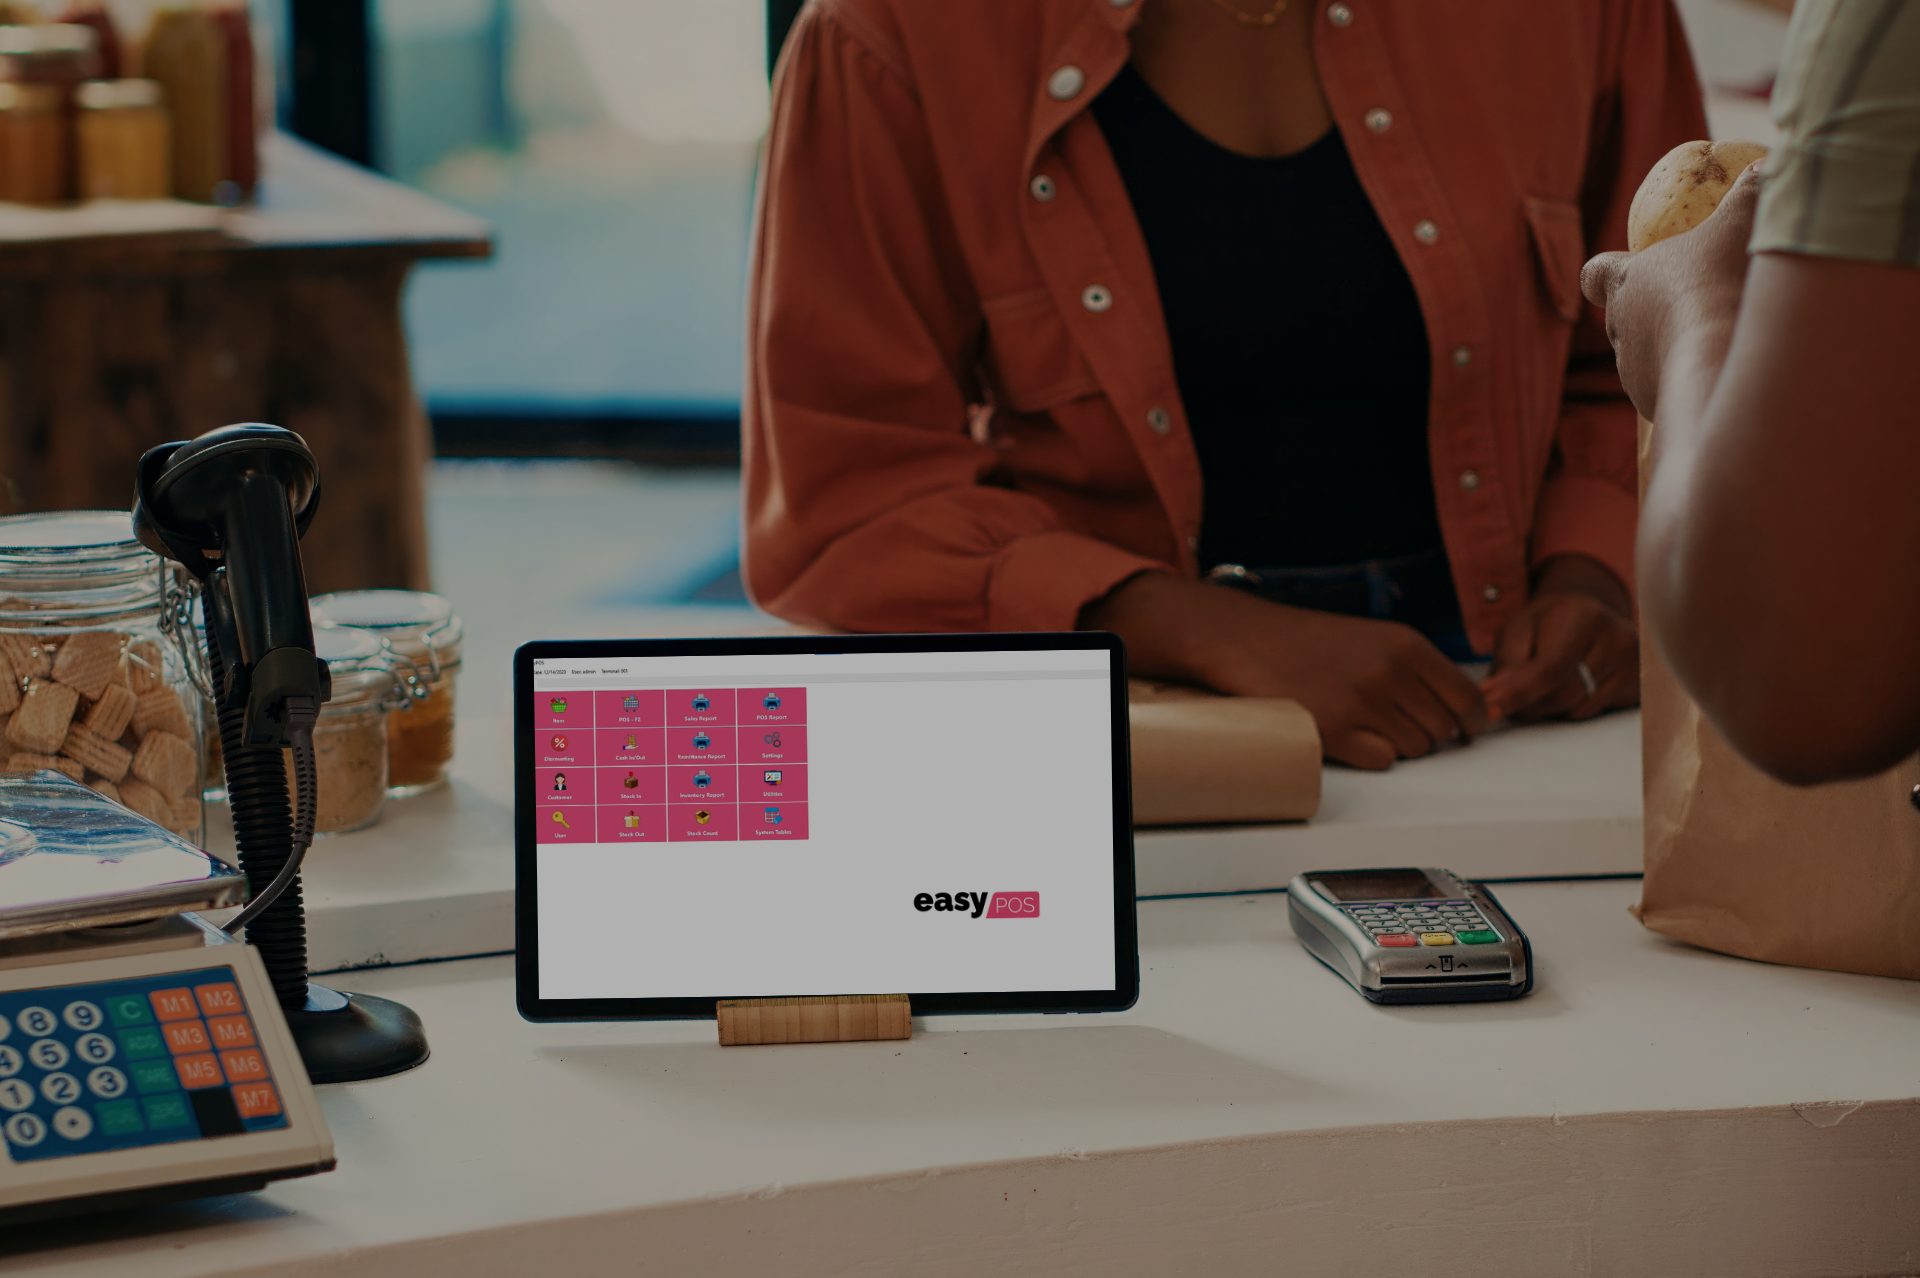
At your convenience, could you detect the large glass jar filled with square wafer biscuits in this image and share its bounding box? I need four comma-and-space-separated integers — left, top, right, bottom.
0, 510, 211, 842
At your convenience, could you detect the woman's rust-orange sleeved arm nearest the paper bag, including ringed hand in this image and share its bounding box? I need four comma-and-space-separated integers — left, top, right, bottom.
1486, 0, 1707, 720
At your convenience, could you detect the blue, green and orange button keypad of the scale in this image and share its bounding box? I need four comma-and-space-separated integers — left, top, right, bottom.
0, 967, 288, 1163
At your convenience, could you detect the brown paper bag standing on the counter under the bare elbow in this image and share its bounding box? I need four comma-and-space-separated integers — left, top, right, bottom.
1634, 412, 1920, 979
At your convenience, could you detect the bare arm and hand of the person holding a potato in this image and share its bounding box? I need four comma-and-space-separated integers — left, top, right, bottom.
1588, 175, 1920, 781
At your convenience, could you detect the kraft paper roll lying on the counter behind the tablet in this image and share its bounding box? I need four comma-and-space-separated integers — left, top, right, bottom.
1129, 683, 1321, 825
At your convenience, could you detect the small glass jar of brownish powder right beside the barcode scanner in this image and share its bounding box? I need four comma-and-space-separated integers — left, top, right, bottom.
299, 626, 411, 835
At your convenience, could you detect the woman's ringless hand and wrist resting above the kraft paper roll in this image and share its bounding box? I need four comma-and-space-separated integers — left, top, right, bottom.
1081, 572, 1488, 769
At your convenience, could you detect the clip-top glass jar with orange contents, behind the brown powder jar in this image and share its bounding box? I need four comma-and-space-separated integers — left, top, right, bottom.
313, 591, 467, 796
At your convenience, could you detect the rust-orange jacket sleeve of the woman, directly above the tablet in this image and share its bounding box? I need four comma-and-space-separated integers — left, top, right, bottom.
745, 6, 1160, 629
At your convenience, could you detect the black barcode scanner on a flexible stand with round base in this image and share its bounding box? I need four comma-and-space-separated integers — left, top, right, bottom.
132, 422, 426, 1082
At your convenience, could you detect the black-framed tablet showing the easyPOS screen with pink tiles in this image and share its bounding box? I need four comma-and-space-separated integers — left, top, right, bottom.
515, 633, 1140, 1021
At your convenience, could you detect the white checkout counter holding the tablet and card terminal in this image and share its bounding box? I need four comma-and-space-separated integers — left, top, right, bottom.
0, 614, 1920, 1278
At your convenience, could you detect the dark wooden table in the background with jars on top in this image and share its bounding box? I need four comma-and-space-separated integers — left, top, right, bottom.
0, 136, 492, 593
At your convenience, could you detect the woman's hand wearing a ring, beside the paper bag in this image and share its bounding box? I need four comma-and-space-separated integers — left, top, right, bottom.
1480, 555, 1640, 723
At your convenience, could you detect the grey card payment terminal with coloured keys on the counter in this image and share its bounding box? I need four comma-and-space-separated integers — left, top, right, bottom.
1286, 869, 1534, 1004
